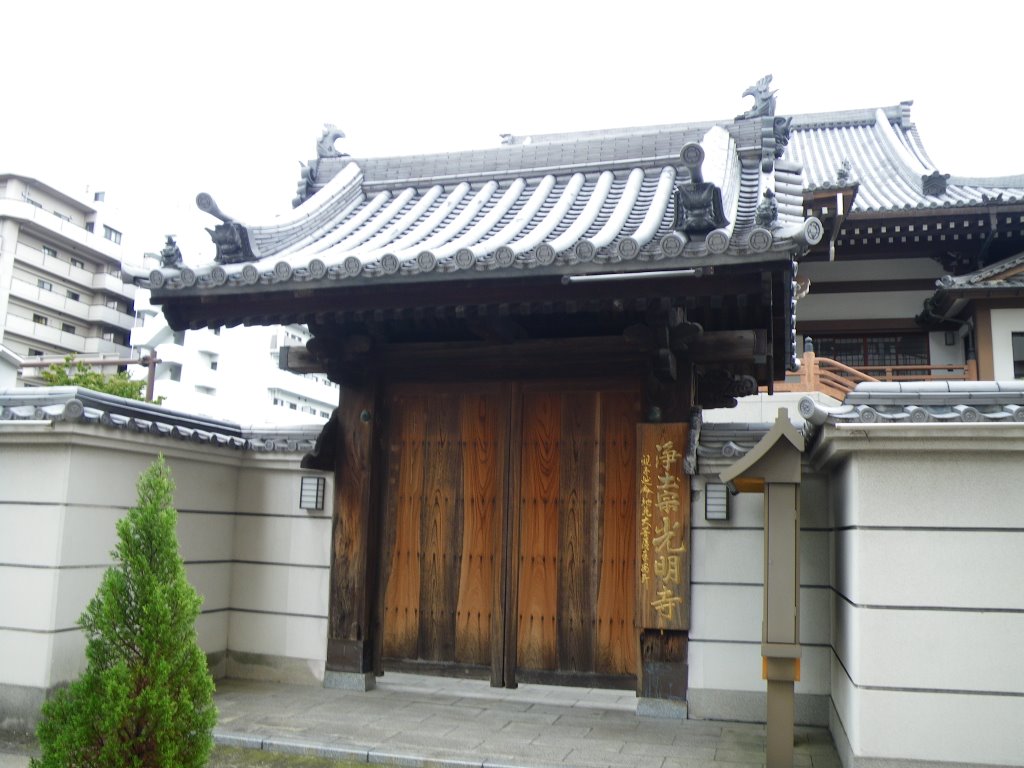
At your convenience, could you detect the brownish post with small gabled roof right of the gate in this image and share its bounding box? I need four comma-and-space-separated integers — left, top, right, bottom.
720, 409, 804, 768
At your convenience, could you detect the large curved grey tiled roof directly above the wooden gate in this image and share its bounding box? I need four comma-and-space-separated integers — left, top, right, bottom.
134, 120, 821, 294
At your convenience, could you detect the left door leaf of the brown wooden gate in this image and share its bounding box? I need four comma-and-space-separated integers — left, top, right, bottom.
381, 385, 509, 683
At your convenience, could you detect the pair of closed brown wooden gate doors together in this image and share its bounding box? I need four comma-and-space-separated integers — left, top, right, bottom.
379, 384, 640, 687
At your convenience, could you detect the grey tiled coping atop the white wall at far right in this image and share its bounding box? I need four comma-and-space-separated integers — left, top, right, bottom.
799, 381, 1024, 426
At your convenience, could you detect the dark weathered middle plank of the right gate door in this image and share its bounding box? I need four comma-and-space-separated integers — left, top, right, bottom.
557, 391, 600, 672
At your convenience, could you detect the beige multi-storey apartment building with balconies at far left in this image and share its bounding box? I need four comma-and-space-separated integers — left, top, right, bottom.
0, 173, 135, 374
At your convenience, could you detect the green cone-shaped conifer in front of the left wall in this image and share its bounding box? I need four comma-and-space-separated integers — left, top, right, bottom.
32, 457, 217, 768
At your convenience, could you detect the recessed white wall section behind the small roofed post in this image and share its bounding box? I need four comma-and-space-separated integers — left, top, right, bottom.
687, 472, 831, 725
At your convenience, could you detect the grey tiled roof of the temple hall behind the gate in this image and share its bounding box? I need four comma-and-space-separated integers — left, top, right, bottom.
786, 101, 1024, 212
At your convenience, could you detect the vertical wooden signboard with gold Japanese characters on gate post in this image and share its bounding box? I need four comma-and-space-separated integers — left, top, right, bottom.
637, 424, 690, 630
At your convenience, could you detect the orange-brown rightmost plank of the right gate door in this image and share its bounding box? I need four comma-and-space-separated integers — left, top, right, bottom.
596, 391, 640, 675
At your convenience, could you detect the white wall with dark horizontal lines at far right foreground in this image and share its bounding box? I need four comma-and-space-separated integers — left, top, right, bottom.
818, 424, 1024, 766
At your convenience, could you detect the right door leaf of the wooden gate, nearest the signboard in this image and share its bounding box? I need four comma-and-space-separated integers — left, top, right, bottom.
513, 385, 640, 686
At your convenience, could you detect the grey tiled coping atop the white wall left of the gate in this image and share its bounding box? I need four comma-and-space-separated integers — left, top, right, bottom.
0, 387, 321, 453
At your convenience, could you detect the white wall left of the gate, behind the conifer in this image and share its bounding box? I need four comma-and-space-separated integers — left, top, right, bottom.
0, 422, 332, 728
